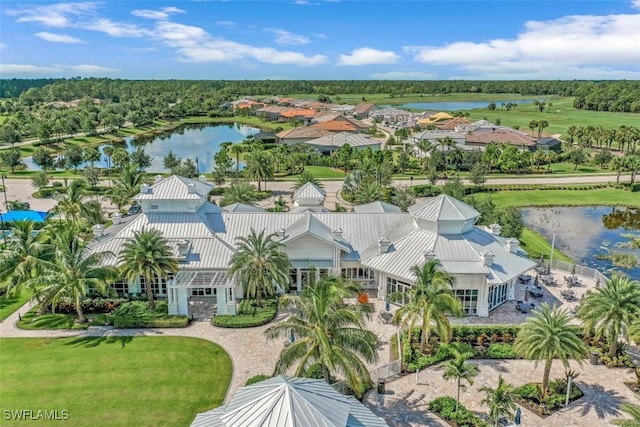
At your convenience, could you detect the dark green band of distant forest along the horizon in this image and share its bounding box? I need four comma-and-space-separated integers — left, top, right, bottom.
0, 77, 640, 113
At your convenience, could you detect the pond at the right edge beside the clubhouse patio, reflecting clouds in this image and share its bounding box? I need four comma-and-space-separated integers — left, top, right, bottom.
522, 206, 640, 280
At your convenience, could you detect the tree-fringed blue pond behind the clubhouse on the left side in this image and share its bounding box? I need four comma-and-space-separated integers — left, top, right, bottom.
23, 123, 260, 172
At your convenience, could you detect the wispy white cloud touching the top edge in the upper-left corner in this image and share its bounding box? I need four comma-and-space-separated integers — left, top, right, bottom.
7, 2, 96, 28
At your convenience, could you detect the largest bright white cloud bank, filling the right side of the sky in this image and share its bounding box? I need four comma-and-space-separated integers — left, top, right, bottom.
404, 13, 640, 79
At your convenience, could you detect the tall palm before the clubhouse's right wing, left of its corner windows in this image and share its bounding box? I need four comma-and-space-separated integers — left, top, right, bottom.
390, 260, 463, 353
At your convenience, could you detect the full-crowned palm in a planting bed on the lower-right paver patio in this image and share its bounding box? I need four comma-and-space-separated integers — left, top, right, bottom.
513, 303, 587, 393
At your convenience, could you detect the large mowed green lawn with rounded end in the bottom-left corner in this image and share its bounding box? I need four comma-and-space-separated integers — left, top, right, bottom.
0, 337, 232, 427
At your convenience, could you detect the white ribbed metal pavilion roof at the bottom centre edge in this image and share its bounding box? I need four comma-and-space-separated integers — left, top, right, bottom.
191, 375, 387, 427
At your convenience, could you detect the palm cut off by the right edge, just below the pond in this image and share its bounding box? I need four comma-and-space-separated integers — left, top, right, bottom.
578, 275, 640, 357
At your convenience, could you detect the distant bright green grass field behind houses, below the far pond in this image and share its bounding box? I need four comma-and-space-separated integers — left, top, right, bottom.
468, 96, 640, 137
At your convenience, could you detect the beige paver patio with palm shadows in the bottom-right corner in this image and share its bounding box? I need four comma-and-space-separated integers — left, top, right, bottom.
365, 360, 637, 427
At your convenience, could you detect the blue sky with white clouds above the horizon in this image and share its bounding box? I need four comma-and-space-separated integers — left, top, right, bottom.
0, 0, 640, 80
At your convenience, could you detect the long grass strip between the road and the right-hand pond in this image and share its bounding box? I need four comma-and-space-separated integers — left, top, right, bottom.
477, 188, 640, 211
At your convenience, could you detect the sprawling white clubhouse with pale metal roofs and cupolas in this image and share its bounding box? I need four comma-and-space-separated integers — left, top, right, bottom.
90, 176, 536, 317
